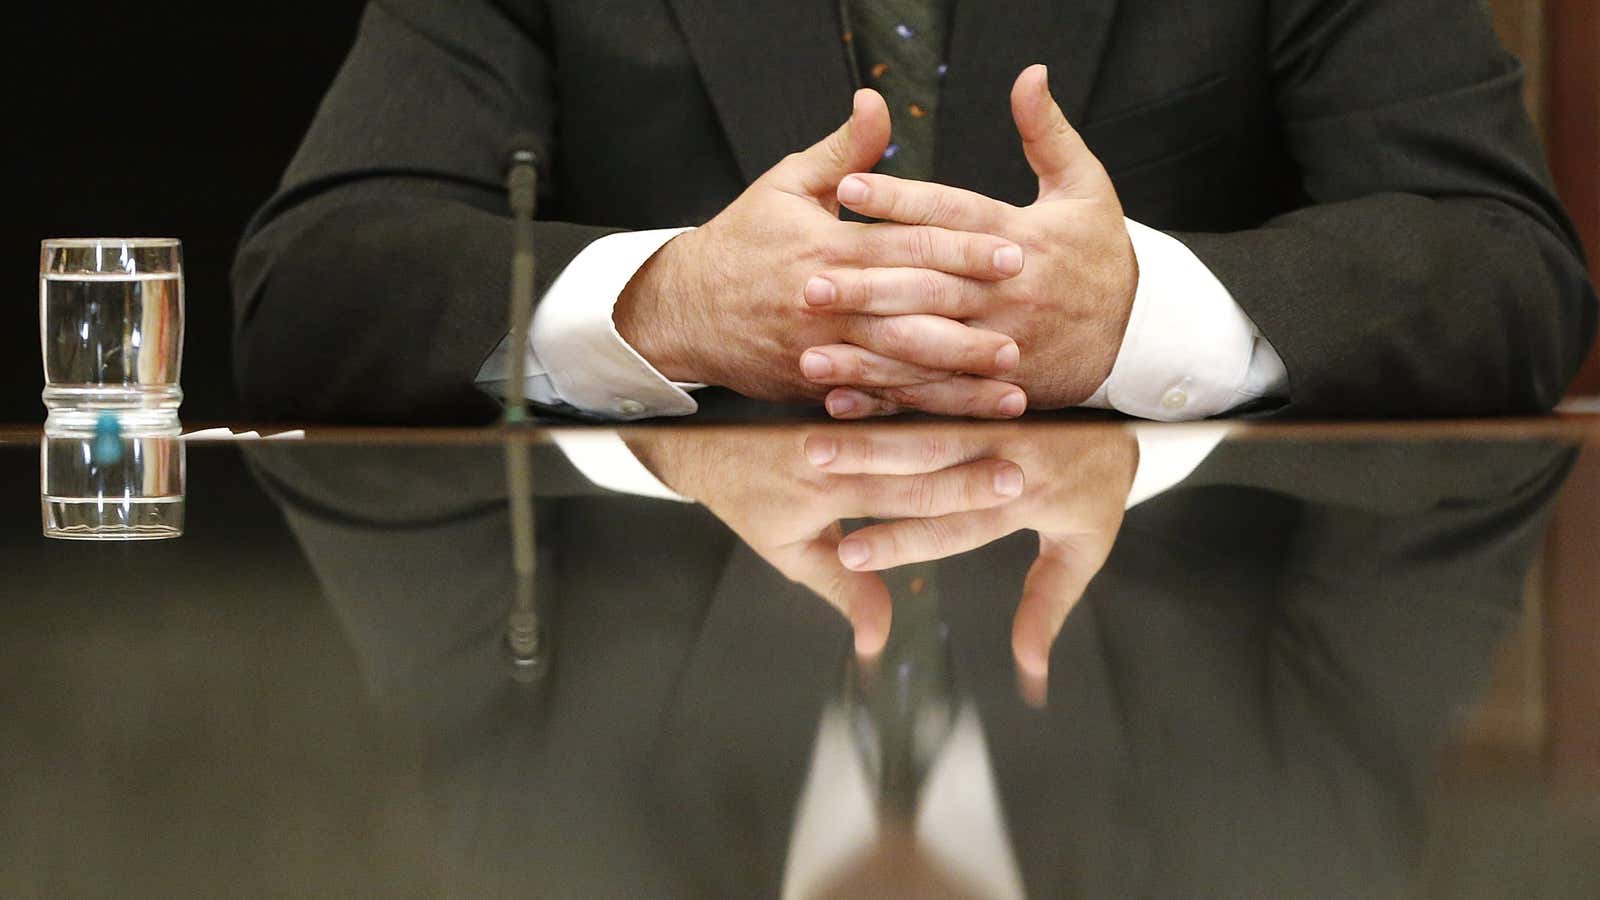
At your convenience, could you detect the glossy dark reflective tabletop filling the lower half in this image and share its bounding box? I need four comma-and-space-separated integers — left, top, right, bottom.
0, 415, 1600, 898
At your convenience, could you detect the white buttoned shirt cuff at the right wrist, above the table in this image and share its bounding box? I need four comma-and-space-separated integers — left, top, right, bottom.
1083, 219, 1288, 421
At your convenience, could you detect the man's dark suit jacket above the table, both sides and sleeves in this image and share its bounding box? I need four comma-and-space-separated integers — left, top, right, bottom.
234, 0, 1594, 421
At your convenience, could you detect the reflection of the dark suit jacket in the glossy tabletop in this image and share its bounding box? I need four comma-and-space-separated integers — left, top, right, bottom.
253, 444, 1568, 897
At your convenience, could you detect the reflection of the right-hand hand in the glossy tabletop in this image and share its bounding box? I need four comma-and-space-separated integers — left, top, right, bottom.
805, 429, 1139, 697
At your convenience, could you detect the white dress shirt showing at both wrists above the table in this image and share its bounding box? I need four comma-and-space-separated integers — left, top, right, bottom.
477, 219, 1288, 421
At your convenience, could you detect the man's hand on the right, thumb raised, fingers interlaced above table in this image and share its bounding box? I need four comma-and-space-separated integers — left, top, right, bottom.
800, 66, 1139, 418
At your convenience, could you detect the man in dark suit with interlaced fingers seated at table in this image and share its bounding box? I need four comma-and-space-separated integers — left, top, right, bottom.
235, 0, 1594, 420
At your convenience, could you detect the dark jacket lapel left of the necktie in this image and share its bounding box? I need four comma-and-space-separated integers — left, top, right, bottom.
670, 0, 854, 181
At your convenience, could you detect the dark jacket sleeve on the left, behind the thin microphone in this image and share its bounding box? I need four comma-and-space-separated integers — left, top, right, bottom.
234, 0, 616, 421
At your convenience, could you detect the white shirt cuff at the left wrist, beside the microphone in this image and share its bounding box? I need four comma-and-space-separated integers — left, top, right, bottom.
477, 227, 699, 420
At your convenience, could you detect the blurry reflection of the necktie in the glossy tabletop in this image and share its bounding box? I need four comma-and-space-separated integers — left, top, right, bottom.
850, 564, 955, 822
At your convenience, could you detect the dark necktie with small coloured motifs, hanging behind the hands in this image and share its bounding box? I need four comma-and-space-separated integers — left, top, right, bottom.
842, 0, 950, 181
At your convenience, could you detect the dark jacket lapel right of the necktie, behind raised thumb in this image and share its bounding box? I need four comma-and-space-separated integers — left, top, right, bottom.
934, 0, 1117, 203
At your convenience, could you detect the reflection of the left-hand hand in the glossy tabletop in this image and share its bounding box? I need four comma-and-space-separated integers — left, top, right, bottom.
627, 431, 1024, 655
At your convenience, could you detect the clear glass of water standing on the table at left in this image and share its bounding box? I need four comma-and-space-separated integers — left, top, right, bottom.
38, 237, 184, 432
